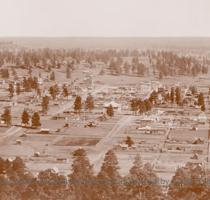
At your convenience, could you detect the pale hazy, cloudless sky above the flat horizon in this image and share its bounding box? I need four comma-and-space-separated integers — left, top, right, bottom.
0, 0, 210, 37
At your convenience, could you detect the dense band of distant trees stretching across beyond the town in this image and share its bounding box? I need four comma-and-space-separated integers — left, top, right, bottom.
0, 48, 210, 80
